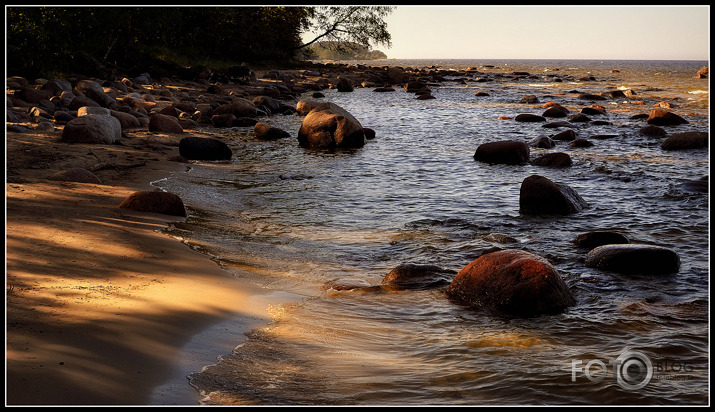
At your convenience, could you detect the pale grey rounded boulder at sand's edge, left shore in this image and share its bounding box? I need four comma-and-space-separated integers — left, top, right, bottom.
61, 114, 122, 144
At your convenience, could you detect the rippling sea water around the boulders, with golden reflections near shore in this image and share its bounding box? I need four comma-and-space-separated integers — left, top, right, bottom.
152, 60, 710, 405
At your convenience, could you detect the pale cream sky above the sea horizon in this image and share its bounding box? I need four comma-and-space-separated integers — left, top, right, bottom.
373, 5, 710, 60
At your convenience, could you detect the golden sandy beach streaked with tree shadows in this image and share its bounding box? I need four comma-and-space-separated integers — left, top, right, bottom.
5, 127, 286, 405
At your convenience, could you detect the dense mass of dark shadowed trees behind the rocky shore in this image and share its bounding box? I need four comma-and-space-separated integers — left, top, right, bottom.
6, 6, 311, 77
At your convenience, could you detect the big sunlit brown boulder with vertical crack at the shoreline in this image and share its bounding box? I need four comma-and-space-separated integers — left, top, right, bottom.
298, 103, 366, 148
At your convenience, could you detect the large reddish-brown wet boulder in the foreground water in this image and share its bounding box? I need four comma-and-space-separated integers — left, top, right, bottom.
447, 249, 576, 317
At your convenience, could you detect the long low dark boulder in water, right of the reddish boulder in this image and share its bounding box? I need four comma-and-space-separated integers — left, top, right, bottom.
585, 244, 680, 275
